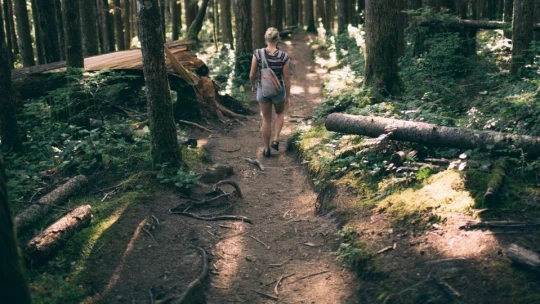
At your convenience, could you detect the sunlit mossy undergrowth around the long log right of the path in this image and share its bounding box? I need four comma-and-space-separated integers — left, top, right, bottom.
292, 17, 540, 303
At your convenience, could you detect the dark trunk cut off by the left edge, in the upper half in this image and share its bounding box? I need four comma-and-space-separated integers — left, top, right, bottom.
0, 7, 22, 152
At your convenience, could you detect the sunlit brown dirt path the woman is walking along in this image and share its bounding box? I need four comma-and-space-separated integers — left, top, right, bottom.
208, 34, 358, 303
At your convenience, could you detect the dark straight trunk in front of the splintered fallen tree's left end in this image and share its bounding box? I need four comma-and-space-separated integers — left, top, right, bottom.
63, 0, 84, 68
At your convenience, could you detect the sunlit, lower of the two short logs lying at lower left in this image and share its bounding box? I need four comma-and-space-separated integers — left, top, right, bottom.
24, 205, 92, 264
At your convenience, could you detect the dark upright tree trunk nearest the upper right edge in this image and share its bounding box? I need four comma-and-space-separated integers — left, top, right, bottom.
510, 0, 535, 75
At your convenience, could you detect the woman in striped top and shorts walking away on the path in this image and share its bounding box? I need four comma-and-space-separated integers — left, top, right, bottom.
249, 27, 291, 157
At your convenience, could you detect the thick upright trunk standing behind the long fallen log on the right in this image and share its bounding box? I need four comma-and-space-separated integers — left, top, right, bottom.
365, 0, 402, 95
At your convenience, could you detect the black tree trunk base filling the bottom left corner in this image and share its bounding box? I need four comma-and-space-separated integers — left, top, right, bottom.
0, 156, 31, 304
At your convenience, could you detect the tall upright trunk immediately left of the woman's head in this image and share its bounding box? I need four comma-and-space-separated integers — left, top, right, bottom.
234, 0, 253, 77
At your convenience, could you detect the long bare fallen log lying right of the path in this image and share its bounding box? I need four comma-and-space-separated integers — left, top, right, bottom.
325, 113, 540, 156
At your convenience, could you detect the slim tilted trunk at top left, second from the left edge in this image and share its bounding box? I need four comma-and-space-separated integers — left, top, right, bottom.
14, 0, 36, 67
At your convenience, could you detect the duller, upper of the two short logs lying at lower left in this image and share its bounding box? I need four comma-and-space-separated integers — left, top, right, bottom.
14, 175, 88, 230
